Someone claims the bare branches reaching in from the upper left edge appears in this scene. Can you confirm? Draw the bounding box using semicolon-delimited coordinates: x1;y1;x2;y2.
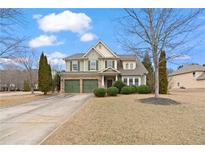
0;9;26;58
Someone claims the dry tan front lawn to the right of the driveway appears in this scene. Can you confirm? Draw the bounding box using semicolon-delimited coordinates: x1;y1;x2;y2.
43;91;205;144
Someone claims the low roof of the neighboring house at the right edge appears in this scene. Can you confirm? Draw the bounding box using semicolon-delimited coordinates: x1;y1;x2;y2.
169;64;205;76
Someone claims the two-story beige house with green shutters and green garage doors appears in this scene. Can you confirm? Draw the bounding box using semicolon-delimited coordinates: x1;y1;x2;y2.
60;41;147;93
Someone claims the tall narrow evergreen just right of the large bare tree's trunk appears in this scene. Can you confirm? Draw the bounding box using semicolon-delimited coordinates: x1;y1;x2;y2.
159;51;168;94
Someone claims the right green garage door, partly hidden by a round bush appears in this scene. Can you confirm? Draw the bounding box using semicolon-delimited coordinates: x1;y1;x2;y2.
83;79;98;93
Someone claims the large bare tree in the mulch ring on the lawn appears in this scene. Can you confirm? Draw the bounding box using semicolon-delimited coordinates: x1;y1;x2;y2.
119;8;203;98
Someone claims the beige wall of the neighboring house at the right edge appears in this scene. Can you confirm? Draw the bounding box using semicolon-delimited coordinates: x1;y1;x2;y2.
168;72;205;89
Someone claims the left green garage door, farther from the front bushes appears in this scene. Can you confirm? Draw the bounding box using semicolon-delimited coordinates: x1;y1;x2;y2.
65;80;80;93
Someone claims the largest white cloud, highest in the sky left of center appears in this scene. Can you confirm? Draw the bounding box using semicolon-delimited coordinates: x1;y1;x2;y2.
38;10;92;34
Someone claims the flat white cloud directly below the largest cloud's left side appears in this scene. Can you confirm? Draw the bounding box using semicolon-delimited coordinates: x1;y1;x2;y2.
29;35;63;48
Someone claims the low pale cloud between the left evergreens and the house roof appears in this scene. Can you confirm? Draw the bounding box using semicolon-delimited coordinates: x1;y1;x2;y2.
46;51;66;65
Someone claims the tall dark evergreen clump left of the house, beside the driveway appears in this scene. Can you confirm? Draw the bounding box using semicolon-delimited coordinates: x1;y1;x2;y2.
38;53;52;95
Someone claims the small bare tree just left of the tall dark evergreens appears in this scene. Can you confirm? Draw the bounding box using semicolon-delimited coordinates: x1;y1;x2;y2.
16;50;38;94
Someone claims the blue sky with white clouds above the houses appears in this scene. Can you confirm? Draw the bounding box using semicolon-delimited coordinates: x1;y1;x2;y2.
1;9;205;69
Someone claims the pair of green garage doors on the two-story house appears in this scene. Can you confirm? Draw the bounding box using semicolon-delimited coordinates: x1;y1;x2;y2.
64;79;98;93
